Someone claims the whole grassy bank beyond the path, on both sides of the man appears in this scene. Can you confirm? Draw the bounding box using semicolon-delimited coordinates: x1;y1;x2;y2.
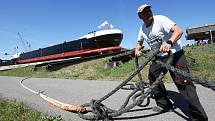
0;44;215;82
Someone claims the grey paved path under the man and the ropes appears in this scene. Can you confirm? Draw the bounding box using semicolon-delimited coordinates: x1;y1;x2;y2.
0;76;215;121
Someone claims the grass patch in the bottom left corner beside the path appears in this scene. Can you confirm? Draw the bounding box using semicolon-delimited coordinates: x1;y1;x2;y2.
0;98;62;121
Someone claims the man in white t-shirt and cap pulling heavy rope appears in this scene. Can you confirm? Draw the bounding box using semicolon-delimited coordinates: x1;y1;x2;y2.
135;4;208;121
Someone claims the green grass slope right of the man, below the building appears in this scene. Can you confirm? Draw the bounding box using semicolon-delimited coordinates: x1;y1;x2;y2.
185;44;215;82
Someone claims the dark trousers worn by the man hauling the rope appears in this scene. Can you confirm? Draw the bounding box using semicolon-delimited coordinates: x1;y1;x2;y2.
148;50;208;121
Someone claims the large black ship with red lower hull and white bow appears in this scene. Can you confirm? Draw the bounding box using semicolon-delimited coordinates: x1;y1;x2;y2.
13;29;123;64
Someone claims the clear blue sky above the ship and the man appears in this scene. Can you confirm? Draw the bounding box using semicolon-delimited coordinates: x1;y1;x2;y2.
0;0;215;59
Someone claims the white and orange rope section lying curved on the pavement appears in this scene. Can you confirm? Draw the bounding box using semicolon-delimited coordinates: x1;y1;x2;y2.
20;77;86;113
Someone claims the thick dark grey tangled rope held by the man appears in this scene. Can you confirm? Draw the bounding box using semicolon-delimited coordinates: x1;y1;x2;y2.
79;52;215;120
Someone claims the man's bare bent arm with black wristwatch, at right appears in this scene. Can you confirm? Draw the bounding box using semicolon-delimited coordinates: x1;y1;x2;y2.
160;25;183;52
